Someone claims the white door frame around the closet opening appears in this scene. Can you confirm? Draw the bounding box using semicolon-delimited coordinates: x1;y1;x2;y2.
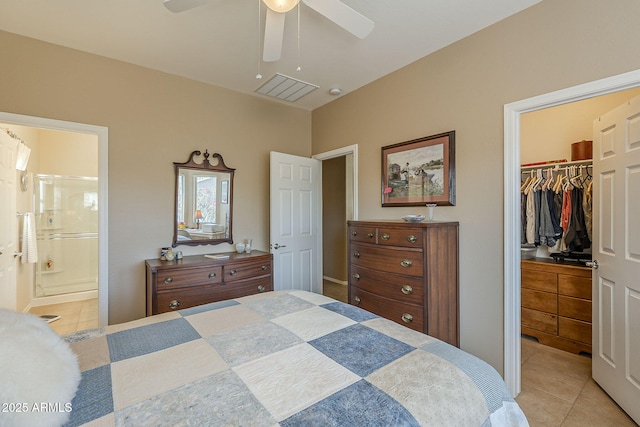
503;70;640;396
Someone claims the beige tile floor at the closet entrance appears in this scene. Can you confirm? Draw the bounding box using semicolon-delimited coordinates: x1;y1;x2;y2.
516;337;637;427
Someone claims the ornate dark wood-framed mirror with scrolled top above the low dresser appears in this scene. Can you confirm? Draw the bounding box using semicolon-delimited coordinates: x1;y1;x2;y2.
173;150;235;247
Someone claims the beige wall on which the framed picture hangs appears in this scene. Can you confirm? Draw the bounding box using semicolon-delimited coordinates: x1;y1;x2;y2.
313;0;640;372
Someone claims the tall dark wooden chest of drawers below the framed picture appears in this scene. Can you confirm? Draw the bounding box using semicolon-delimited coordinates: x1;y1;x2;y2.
348;221;460;347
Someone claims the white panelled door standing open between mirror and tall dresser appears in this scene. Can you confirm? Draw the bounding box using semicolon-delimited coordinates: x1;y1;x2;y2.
270;152;322;293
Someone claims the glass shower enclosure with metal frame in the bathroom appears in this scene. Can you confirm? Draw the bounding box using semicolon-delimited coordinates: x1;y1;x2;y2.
34;175;98;297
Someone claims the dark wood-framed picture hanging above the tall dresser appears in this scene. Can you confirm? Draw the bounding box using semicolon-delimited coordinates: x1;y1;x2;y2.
382;130;456;207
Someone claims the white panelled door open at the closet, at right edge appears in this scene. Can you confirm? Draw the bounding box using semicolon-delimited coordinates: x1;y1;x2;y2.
592;93;640;423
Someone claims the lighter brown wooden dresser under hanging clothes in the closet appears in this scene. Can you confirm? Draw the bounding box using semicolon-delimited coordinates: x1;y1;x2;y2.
521;258;591;353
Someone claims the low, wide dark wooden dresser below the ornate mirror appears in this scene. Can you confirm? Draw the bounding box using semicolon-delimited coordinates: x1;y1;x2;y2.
145;250;273;316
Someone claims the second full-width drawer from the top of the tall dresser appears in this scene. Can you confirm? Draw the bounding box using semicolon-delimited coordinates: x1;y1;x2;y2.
349;266;424;305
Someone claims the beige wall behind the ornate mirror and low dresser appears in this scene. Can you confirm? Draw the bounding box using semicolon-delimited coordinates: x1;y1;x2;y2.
0;32;311;323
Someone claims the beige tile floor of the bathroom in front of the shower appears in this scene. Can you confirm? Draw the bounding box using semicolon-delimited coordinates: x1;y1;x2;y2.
29;298;98;335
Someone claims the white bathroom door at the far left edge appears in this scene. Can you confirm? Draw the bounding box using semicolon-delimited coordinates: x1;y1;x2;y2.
0;131;18;310
